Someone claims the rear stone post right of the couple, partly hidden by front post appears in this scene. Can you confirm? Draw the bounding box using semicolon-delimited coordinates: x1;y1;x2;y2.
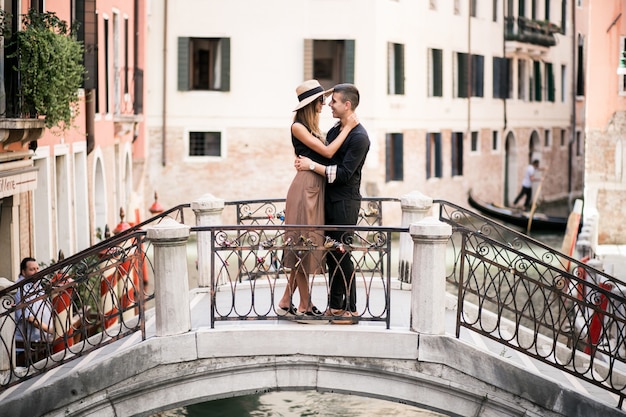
398;191;433;283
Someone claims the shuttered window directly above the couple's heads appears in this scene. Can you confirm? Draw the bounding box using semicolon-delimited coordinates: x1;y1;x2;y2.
304;39;355;88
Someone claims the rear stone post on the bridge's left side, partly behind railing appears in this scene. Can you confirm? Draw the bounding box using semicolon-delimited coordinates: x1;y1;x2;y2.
191;194;224;287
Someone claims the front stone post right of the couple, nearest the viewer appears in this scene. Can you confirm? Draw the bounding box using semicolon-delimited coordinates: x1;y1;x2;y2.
409;217;452;335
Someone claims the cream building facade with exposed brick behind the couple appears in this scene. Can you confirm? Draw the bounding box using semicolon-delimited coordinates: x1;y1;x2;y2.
144;0;584;226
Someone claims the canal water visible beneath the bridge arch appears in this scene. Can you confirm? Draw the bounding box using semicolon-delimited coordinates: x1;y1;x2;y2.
151;391;444;417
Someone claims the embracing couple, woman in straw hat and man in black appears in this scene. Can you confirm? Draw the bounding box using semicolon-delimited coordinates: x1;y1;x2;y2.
277;80;370;324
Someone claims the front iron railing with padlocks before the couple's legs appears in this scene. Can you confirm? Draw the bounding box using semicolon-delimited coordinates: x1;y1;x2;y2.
197;225;400;328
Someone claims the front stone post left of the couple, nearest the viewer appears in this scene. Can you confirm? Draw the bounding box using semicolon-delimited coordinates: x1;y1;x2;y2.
147;218;191;336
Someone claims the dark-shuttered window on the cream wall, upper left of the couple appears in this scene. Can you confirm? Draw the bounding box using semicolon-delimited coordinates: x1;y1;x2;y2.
178;37;230;91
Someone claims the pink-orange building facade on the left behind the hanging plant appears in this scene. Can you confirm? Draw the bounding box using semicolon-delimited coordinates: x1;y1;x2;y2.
0;0;145;279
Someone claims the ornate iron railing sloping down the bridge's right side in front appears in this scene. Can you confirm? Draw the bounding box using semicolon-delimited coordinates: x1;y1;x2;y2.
436;201;626;407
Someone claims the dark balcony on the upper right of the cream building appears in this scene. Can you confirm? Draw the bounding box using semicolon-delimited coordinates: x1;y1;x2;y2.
504;16;561;48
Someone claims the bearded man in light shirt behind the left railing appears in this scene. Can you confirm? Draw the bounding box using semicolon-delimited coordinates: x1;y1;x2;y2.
15;258;54;364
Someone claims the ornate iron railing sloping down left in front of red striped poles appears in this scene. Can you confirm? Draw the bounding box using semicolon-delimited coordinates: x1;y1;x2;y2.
0;205;189;390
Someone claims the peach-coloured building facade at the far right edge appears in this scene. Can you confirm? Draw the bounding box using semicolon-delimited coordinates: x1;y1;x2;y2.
578;0;626;245
